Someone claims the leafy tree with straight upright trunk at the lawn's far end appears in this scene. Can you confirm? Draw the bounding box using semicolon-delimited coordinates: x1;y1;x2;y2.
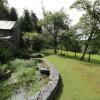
41;11;69;54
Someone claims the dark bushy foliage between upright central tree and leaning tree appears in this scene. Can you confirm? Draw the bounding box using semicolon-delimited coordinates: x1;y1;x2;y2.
59;25;81;55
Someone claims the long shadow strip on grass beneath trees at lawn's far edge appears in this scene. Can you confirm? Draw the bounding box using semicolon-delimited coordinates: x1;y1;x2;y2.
58;54;100;65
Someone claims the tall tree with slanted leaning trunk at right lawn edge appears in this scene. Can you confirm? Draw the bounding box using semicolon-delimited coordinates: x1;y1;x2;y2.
71;0;100;60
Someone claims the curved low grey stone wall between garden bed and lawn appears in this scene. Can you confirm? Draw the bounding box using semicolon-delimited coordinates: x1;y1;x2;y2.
28;60;60;100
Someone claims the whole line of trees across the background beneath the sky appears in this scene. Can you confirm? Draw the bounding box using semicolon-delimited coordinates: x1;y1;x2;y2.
0;0;100;61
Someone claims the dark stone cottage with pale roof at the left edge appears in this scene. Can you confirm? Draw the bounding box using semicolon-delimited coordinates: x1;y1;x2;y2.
0;20;19;48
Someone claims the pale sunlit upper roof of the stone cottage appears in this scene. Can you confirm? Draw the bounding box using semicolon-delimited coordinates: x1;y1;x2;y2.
0;20;16;30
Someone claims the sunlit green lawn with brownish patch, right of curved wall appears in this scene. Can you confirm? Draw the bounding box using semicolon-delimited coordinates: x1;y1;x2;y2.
45;54;100;100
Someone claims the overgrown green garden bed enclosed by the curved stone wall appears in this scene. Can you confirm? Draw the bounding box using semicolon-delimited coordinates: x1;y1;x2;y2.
0;59;48;100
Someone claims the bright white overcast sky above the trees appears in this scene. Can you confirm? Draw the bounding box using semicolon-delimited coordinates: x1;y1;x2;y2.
8;0;82;24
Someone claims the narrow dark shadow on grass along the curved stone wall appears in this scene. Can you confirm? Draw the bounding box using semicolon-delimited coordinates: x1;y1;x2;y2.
53;76;63;100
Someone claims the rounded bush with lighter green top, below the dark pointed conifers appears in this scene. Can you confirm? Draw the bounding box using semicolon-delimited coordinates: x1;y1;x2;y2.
23;32;44;52
